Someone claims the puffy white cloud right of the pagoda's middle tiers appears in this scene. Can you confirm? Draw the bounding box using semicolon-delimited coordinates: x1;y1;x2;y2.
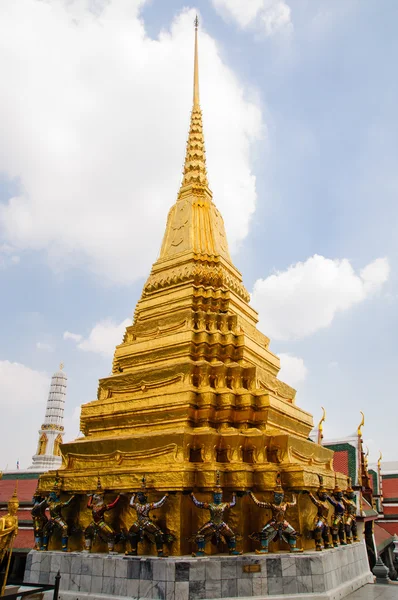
252;254;390;340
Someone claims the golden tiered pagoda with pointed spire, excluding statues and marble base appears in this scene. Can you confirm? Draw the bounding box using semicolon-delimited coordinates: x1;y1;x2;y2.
40;22;345;555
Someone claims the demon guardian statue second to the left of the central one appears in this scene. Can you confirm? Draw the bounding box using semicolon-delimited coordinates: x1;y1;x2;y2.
83;476;120;553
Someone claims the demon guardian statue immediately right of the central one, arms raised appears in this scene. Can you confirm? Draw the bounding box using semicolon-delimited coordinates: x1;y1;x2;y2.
249;473;303;554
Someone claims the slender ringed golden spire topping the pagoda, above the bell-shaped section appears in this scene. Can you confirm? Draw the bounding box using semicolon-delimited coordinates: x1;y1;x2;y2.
179;16;210;197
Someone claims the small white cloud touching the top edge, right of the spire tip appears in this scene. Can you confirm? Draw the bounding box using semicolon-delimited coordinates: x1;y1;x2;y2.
212;0;293;36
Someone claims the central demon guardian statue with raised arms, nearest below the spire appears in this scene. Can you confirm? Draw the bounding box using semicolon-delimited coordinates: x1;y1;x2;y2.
191;471;242;556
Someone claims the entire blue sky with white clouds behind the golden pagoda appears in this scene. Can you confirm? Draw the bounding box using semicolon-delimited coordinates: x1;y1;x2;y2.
0;0;398;470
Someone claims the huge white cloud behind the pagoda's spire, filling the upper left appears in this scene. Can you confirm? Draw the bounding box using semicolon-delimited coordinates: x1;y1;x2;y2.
0;0;263;283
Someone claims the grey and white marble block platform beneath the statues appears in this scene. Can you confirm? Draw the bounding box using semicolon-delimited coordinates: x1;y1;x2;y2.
24;542;373;600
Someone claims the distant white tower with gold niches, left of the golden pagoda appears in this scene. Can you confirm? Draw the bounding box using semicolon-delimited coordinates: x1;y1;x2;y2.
29;363;68;473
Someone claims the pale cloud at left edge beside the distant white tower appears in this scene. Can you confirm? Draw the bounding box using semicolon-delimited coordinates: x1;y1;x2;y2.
0;360;50;470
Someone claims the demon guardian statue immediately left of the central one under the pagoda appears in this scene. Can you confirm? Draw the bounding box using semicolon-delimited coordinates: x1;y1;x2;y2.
128;477;168;556
